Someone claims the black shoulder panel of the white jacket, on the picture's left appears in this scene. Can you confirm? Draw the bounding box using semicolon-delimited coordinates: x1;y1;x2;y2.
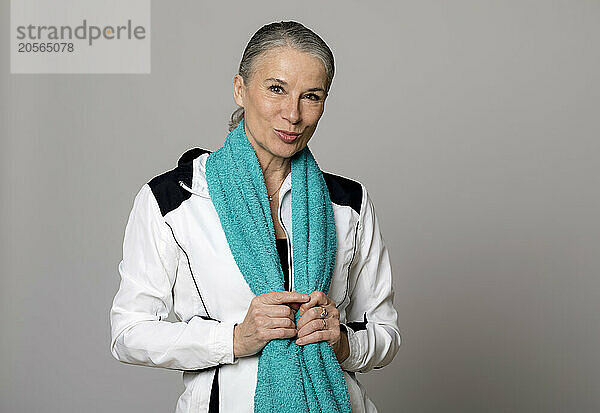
148;148;211;216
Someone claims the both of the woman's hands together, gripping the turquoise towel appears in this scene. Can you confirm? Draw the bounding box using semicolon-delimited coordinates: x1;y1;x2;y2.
233;291;349;362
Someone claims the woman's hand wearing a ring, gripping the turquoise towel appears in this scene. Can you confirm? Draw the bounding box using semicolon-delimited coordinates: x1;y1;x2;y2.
296;291;350;363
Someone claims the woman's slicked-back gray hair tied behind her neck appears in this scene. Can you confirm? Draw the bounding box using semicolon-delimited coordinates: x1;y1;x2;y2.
229;21;335;131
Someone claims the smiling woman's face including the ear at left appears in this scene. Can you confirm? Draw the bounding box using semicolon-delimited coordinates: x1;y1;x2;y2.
234;47;327;160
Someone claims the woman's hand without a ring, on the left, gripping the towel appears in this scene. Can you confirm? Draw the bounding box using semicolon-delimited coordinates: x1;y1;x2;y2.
233;291;310;357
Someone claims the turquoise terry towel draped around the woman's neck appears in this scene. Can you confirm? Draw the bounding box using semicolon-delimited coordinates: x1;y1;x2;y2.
206;120;351;413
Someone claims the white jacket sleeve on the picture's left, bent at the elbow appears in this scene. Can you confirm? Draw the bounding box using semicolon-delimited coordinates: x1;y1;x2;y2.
110;184;237;370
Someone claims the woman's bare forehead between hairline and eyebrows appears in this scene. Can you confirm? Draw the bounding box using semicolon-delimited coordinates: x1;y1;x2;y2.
252;47;327;87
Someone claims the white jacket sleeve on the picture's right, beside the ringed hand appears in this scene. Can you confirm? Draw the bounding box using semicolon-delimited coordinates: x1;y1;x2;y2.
340;185;401;373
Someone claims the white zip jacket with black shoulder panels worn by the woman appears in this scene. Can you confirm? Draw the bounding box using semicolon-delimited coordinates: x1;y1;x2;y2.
110;148;400;413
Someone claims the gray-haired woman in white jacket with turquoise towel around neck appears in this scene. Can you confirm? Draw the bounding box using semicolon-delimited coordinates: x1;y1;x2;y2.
110;21;400;413
